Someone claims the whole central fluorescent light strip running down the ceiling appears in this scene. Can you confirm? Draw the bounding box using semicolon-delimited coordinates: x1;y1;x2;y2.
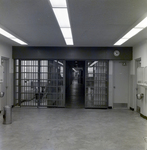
50;0;73;45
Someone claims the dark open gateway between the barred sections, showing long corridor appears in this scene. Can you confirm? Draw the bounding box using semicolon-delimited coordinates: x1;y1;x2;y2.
66;60;85;108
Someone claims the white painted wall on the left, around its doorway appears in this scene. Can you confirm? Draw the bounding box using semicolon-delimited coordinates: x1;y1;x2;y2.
0;42;13;111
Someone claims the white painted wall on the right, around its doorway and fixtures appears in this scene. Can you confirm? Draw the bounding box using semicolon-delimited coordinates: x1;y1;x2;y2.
130;40;147;116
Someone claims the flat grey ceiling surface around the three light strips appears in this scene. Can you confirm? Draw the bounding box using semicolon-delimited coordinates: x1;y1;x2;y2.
0;0;147;46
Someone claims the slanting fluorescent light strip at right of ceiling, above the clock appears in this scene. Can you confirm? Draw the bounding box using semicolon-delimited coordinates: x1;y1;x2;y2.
114;17;147;45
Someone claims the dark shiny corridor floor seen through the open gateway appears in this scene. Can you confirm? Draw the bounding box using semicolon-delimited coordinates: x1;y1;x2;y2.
66;79;84;108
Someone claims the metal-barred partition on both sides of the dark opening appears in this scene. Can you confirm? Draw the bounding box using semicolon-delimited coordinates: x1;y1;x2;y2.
14;59;109;108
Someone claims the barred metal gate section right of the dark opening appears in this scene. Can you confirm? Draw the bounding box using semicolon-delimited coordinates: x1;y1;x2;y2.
85;60;108;108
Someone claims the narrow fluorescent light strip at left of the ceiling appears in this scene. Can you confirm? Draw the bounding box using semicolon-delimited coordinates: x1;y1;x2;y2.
0;28;28;45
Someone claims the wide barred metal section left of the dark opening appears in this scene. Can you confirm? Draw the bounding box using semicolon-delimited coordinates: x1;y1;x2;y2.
14;60;65;107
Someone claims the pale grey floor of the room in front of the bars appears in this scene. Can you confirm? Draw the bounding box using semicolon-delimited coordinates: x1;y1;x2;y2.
0;108;147;150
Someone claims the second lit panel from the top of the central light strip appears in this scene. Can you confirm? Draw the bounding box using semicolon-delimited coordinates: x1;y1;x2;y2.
53;8;70;28
